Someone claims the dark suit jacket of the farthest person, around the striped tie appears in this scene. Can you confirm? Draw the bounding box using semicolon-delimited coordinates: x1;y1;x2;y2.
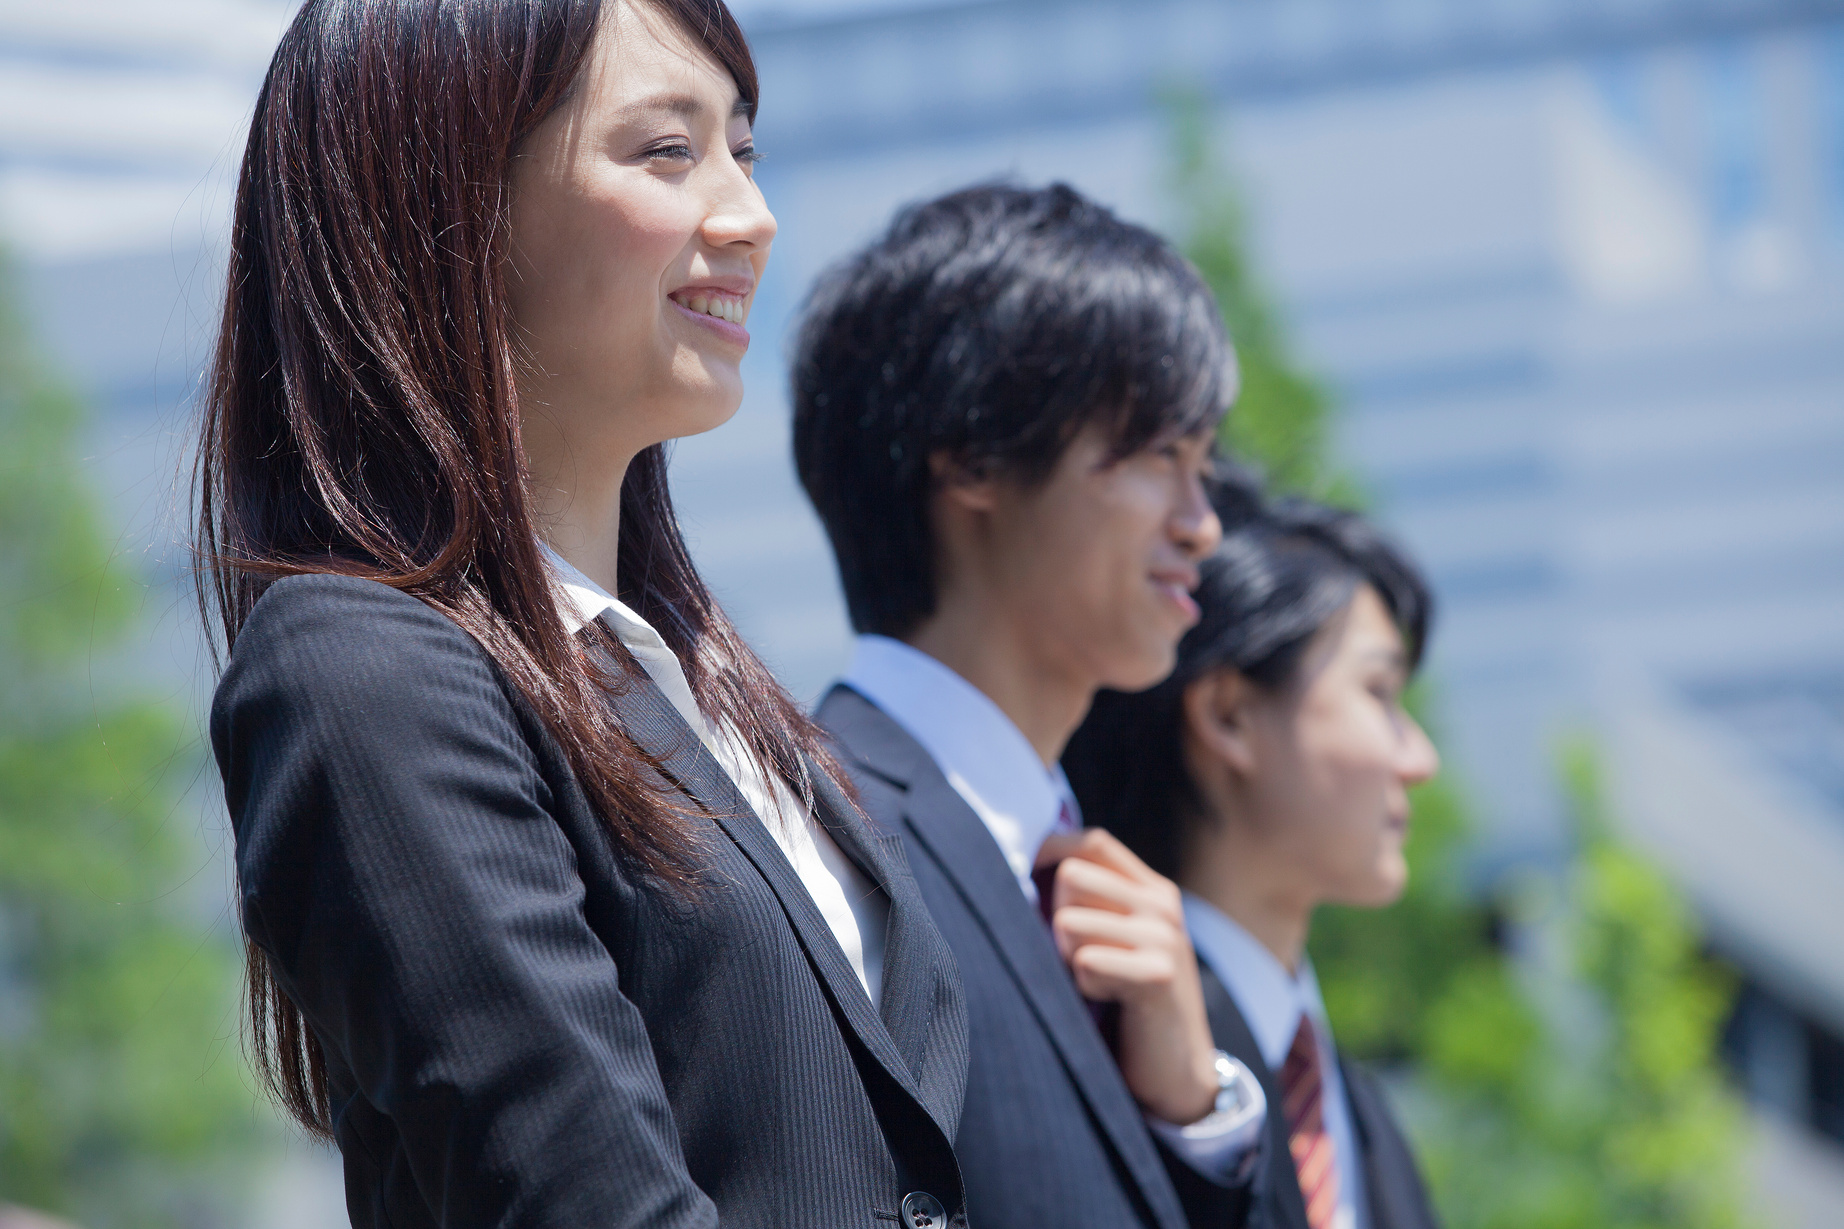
1199;965;1440;1229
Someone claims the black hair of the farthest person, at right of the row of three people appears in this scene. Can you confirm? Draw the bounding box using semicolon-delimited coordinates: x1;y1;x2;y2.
1062;489;1433;878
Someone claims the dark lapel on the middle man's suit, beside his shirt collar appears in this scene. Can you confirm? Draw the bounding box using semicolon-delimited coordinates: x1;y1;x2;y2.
821;686;1186;1229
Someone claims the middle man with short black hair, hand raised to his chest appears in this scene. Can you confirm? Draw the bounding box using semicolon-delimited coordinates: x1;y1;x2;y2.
793;185;1265;1229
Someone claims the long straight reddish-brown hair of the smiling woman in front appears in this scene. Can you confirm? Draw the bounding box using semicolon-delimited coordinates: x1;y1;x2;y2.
195;0;819;1137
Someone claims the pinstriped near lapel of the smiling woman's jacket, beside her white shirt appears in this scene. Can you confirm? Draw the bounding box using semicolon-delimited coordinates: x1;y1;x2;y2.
609;675;953;1139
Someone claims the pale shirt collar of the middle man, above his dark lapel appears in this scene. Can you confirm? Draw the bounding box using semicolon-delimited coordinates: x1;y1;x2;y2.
845;635;1075;897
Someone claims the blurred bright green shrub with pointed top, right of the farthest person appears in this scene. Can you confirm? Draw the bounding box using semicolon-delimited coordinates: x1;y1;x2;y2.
1424;744;1746;1229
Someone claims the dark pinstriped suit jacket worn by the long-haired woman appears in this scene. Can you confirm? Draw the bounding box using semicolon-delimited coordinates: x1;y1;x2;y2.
212;576;966;1229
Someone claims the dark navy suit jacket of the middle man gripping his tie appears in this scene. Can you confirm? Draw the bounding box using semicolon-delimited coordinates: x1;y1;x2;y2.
819;686;1247;1229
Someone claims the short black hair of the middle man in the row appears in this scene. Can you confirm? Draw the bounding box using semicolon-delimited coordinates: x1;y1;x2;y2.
793;185;1235;637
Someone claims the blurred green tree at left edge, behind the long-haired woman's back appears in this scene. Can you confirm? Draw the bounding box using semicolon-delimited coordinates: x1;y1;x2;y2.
0;256;260;1229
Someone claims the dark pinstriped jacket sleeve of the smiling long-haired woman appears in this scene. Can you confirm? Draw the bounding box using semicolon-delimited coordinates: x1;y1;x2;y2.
212;578;717;1229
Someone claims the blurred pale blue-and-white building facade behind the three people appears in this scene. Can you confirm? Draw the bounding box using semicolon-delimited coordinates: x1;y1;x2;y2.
0;0;1844;1210
